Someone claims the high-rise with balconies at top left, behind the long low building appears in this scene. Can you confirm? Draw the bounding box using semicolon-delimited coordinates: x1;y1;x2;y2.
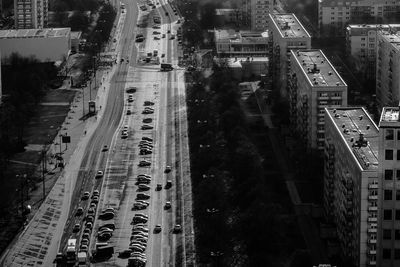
14;0;49;29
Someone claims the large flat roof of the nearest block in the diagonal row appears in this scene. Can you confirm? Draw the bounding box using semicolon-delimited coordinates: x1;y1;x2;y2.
325;107;379;170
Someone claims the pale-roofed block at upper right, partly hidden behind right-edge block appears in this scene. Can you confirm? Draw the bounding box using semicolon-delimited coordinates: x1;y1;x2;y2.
346;24;400;80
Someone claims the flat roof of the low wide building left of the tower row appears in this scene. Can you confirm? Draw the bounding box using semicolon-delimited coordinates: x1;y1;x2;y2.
214;30;269;43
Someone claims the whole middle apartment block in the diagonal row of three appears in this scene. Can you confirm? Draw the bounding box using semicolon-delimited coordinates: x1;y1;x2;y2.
288;49;347;152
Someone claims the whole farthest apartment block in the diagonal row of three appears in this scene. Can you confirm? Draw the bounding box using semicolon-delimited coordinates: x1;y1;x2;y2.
268;13;311;96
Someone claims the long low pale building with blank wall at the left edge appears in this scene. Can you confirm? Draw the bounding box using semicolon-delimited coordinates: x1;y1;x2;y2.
0;28;71;62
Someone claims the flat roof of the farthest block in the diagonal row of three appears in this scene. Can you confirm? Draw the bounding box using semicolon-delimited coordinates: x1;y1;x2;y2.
269;13;311;38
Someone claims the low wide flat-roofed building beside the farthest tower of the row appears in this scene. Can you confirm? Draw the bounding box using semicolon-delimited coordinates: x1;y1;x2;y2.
214;30;269;57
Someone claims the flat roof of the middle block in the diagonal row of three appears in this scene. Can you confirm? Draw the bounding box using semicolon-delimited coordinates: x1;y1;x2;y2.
291;49;347;87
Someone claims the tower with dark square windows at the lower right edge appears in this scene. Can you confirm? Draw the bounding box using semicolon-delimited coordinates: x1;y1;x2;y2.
376;106;400;267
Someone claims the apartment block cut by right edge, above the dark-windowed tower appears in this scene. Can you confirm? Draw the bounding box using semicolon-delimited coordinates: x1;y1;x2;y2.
376;32;400;110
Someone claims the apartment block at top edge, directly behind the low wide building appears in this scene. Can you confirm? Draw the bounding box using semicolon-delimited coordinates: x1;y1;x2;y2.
242;0;276;32
